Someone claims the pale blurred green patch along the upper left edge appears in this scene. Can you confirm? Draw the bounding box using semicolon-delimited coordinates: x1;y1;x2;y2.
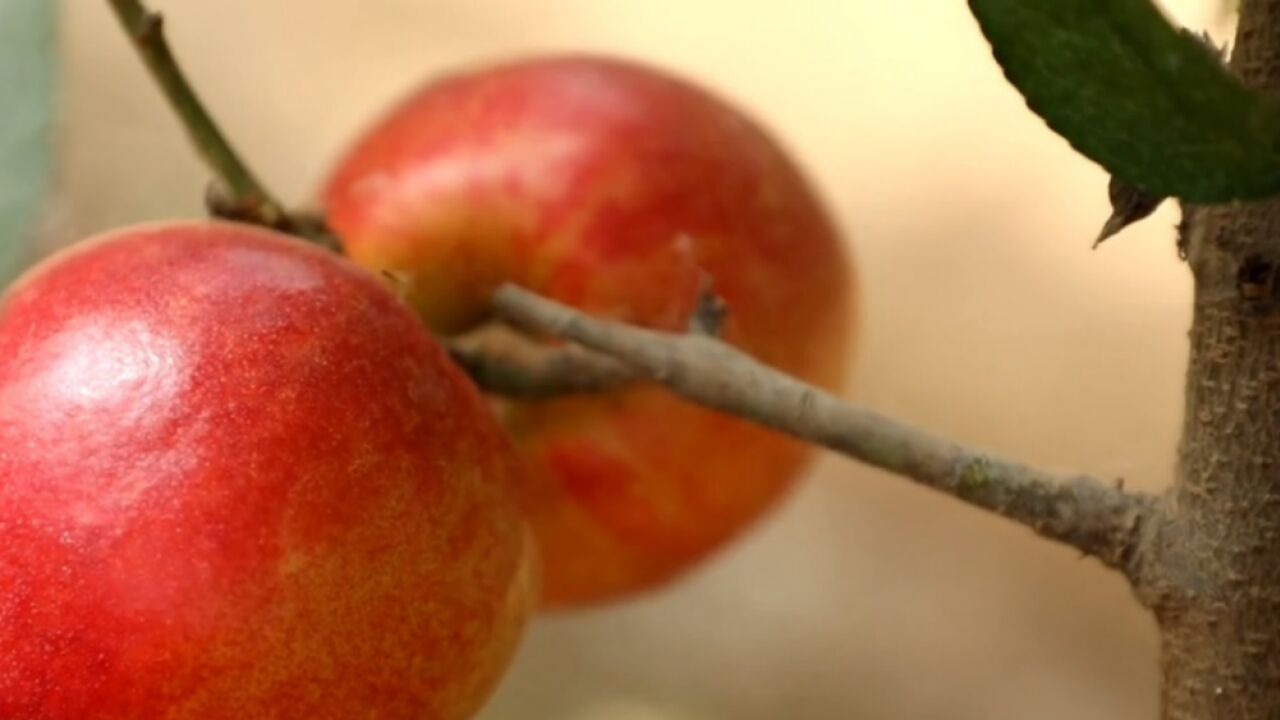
0;0;58;286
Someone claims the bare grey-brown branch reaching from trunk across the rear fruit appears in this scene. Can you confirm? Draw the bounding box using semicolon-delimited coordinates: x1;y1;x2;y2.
494;284;1153;573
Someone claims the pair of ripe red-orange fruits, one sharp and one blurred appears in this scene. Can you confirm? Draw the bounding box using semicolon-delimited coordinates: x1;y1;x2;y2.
0;58;850;720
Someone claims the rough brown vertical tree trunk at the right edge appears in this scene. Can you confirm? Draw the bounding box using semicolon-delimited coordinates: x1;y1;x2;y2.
1133;0;1280;720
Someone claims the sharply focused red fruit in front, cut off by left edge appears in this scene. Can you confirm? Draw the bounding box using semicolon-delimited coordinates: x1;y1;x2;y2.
0;222;536;720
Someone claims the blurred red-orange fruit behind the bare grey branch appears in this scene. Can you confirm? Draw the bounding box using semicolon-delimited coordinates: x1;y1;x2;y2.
323;56;854;607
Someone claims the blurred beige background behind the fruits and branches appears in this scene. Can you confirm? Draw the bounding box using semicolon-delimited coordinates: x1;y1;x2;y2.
50;0;1226;720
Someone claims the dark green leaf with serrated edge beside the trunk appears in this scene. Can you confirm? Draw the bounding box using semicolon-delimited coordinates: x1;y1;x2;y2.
969;0;1280;202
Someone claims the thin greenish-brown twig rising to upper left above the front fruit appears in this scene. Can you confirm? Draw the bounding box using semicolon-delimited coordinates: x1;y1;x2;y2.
110;0;338;250
